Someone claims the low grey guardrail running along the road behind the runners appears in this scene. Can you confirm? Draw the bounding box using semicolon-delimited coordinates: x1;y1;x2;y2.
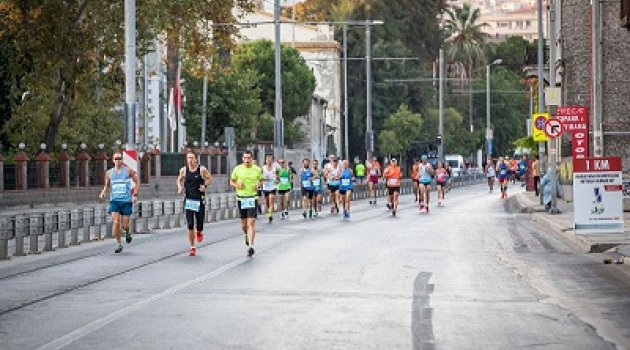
0;175;485;260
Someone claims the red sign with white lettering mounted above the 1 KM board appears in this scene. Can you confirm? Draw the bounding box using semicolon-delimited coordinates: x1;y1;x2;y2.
556;106;589;163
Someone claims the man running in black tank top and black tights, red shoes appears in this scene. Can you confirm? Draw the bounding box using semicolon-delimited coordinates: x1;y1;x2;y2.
177;151;212;256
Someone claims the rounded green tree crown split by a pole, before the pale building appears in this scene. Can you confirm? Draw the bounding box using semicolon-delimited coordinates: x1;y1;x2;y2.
232;40;315;122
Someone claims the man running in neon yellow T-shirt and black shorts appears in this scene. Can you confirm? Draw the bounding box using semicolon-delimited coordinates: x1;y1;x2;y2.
230;150;262;257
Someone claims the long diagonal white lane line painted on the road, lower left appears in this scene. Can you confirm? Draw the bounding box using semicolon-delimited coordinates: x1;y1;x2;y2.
37;258;250;350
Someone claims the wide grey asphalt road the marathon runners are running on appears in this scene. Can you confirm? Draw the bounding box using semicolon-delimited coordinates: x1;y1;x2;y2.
0;185;630;350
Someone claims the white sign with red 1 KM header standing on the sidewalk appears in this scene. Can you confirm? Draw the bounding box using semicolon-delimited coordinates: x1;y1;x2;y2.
573;157;623;233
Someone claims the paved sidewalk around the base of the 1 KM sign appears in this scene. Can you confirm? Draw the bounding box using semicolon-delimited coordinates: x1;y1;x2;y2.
512;192;630;256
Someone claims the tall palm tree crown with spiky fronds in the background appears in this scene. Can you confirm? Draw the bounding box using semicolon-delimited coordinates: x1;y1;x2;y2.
444;3;490;77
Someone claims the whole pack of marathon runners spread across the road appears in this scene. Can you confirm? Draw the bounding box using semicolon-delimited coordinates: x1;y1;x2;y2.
100;151;456;257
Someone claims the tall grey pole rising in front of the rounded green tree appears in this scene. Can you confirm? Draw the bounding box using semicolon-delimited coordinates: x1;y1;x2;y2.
273;0;284;159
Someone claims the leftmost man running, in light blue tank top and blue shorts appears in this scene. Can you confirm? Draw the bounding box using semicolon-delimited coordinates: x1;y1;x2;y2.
99;151;140;253
